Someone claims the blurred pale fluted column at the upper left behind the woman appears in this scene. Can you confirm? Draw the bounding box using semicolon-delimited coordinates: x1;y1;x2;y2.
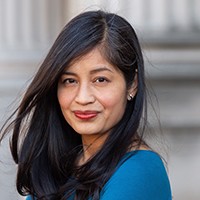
0;0;62;56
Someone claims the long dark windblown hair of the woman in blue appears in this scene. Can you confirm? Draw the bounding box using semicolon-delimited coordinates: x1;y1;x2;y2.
1;11;146;200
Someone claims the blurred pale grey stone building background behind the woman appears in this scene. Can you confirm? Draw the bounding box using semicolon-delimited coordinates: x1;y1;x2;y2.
0;0;200;200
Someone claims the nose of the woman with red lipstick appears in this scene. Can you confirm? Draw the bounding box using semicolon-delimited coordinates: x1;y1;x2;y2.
75;84;95;105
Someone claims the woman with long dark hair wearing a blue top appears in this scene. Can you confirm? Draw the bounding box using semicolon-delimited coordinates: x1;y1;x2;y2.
0;11;171;200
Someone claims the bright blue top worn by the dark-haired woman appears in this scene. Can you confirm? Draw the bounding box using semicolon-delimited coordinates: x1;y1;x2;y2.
26;150;172;200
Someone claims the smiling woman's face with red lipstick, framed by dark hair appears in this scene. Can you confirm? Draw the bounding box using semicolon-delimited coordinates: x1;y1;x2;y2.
57;49;131;141
